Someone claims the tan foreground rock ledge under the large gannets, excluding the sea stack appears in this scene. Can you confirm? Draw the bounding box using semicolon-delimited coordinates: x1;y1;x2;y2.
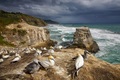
0;48;120;80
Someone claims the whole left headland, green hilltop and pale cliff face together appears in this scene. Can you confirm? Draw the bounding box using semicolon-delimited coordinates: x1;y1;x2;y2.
0;10;50;46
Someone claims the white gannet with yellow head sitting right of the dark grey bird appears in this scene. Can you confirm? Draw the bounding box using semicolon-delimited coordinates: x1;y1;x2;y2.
39;55;55;69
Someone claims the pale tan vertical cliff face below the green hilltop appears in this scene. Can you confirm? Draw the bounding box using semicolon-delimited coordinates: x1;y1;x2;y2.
1;22;50;46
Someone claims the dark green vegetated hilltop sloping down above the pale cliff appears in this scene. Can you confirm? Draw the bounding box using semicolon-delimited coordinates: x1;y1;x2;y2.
0;10;47;27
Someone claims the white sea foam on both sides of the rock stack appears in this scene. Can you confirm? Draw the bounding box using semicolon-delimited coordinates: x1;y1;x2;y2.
48;24;120;57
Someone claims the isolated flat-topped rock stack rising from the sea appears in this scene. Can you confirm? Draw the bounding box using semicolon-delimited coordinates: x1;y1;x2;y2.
73;27;99;53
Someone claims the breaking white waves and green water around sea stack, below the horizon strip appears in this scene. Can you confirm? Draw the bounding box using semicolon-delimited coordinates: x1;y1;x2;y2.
47;24;120;63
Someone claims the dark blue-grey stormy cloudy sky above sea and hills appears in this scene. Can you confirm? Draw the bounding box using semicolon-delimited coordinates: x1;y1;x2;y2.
0;0;120;23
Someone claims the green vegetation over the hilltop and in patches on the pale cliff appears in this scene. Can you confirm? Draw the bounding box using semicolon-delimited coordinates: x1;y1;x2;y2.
0;10;47;45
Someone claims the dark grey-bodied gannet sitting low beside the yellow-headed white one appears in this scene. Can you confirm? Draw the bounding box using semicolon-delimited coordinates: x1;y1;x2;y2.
23;59;40;74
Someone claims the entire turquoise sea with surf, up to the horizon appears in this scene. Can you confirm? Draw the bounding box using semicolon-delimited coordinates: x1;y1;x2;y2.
47;24;120;64
